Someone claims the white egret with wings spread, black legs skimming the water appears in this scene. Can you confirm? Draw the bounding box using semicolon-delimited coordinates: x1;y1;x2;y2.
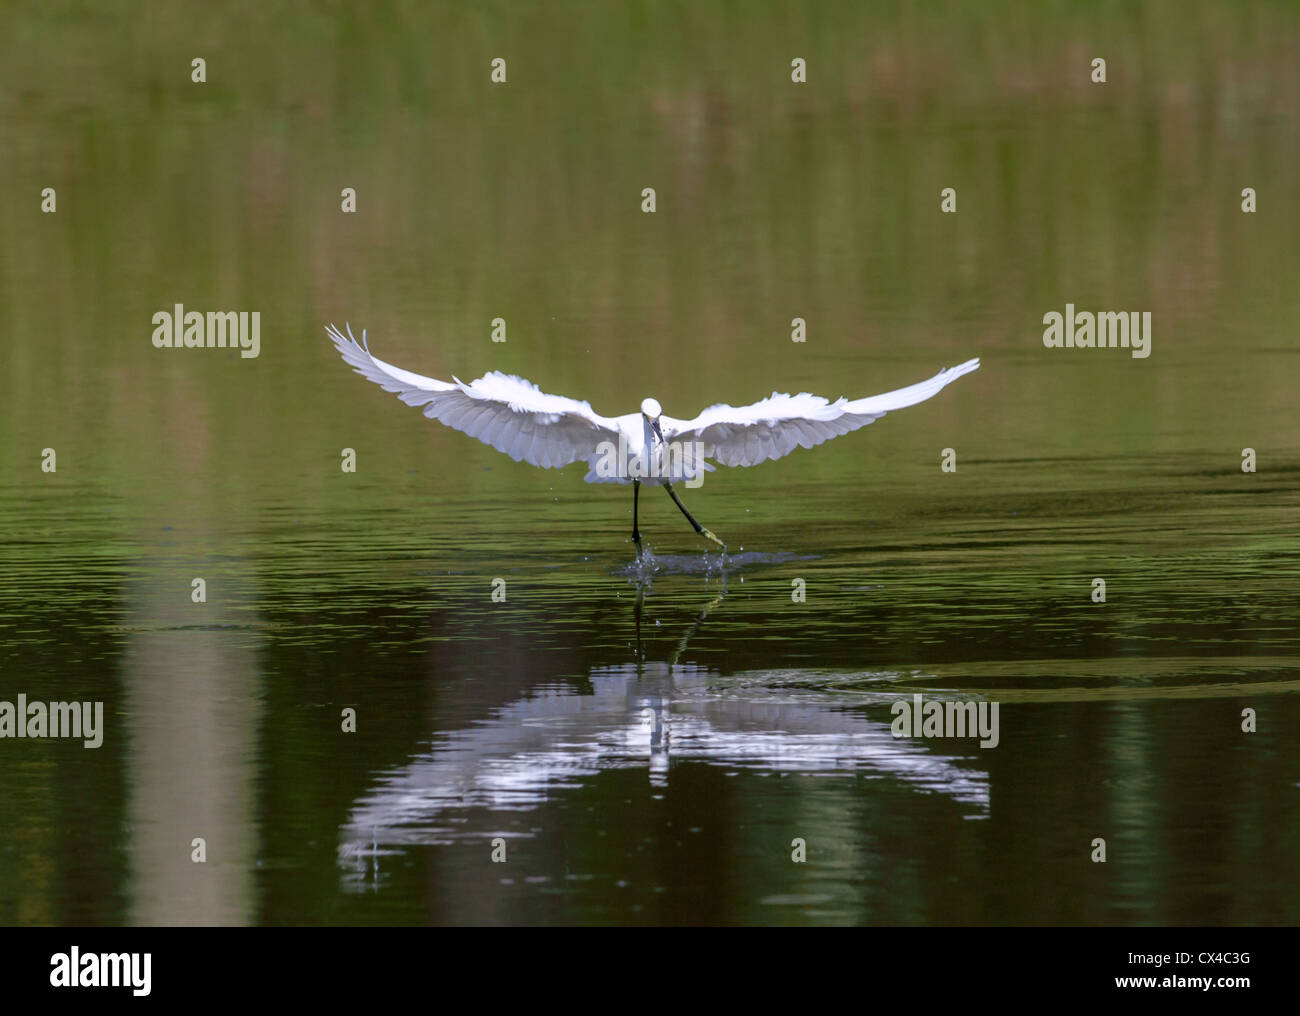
326;325;979;550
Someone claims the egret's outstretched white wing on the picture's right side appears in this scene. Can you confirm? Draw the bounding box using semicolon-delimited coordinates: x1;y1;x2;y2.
659;359;979;465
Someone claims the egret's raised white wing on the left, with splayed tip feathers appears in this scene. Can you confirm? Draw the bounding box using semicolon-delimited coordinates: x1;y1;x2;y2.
325;325;619;469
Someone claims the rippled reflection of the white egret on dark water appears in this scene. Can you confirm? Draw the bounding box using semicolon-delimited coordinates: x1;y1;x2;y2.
338;573;989;890
